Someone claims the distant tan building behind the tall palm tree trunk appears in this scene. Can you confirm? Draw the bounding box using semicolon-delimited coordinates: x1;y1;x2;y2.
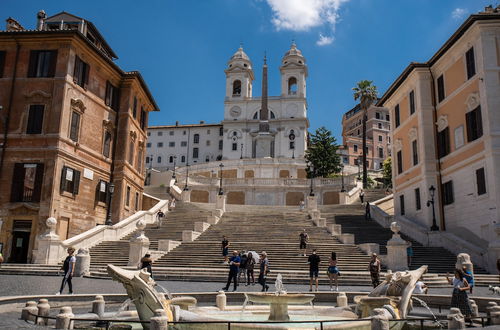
342;104;391;170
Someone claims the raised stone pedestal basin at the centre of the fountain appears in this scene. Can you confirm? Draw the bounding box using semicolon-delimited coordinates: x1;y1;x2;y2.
245;293;315;321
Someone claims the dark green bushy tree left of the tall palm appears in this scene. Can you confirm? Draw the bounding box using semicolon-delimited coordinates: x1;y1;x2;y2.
305;127;340;178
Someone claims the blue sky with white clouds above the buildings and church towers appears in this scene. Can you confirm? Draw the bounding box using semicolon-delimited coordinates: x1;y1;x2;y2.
0;0;496;143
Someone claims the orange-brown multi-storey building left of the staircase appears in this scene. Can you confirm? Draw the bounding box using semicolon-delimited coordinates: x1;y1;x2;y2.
0;11;158;262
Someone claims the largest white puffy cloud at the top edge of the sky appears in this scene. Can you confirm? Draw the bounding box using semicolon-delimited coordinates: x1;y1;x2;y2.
266;0;349;31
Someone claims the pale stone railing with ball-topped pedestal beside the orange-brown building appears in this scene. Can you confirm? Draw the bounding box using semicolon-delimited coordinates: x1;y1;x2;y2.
34;196;168;264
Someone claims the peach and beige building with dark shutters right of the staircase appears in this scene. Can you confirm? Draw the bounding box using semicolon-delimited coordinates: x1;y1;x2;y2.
377;7;500;271
